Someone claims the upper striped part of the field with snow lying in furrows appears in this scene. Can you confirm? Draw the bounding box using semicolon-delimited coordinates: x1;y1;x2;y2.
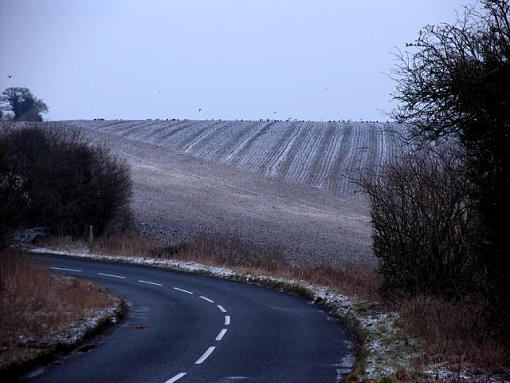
73;120;403;196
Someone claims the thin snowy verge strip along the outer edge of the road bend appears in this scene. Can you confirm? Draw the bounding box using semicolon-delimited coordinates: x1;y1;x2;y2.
29;247;430;381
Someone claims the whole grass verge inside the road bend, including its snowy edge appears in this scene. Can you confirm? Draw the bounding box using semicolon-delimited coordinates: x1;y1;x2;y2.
0;250;123;379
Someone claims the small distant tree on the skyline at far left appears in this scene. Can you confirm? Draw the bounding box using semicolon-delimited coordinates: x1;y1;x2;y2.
0;87;48;121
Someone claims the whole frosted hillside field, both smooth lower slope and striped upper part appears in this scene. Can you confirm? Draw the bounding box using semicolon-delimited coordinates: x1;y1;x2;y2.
67;120;408;264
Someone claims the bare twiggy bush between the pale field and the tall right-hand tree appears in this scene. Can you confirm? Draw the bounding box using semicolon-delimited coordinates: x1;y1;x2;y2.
362;147;483;299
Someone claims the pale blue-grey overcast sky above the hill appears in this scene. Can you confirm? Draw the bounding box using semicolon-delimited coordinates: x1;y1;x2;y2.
0;0;467;120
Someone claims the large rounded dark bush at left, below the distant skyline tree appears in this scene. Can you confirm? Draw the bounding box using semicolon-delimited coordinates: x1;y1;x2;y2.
0;124;131;242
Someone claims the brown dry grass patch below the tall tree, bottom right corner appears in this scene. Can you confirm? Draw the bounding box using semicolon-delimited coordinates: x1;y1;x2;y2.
399;297;510;377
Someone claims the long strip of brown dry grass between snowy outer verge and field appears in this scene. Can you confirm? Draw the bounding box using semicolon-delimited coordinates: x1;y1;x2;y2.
44;230;381;300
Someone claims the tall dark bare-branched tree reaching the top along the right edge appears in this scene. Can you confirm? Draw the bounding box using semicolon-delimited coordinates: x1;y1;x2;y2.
394;0;510;330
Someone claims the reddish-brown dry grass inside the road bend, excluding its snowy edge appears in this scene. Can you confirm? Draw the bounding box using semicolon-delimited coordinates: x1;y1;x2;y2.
0;250;114;371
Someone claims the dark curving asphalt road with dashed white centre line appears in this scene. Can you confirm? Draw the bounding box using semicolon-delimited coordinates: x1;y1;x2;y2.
26;257;352;383
